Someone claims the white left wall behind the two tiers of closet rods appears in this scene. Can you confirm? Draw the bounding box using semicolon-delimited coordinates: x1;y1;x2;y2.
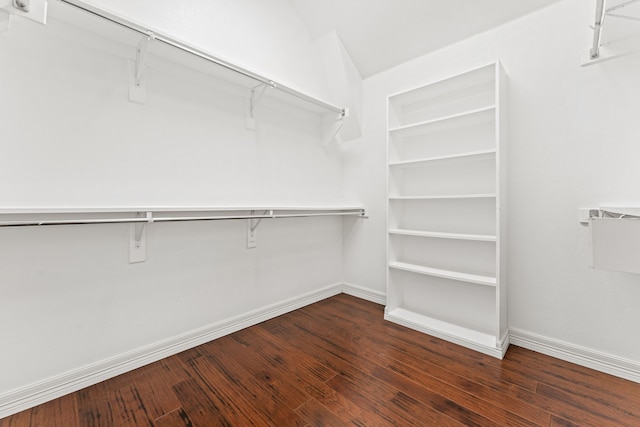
0;0;350;417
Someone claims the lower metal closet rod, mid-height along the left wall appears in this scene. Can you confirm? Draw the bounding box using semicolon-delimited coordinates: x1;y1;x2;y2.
0;209;365;227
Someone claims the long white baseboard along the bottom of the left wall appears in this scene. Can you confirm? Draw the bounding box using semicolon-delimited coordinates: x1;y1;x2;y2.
0;283;344;419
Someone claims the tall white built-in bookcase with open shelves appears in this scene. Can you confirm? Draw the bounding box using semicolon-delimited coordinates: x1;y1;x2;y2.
385;62;508;358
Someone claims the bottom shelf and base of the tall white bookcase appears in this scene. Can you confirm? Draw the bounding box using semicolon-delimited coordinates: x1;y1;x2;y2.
384;308;502;358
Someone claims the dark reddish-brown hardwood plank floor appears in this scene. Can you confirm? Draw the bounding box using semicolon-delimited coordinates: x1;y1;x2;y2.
0;295;640;427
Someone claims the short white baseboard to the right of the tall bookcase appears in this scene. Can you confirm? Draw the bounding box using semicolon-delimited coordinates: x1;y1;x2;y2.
510;328;640;383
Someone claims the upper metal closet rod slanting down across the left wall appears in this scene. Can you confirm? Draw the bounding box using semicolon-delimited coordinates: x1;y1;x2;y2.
58;0;346;117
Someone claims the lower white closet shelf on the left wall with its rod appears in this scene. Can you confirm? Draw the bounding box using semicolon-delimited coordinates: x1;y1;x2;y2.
0;206;366;227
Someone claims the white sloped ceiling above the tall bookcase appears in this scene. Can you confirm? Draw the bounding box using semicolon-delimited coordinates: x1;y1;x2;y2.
289;0;562;78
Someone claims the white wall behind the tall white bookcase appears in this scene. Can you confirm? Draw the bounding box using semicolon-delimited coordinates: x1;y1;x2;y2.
343;0;640;367
